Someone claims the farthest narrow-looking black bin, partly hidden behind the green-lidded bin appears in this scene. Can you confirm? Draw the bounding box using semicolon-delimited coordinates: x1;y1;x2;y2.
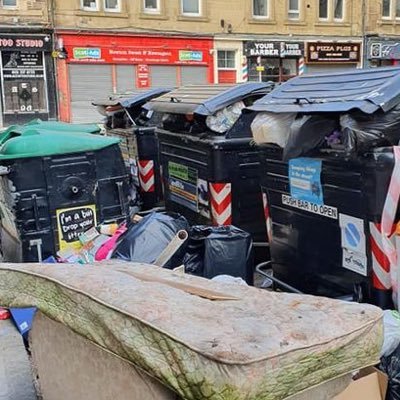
93;88;171;210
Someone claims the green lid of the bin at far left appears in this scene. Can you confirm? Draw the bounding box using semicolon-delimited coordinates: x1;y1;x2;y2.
0;127;119;161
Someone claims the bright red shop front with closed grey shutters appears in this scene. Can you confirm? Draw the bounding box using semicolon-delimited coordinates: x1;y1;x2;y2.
57;33;214;122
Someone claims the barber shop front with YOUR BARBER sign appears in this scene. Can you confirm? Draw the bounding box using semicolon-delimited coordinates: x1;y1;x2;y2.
243;41;304;82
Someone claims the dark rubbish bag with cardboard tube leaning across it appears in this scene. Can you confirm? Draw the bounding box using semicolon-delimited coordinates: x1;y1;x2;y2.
111;213;189;268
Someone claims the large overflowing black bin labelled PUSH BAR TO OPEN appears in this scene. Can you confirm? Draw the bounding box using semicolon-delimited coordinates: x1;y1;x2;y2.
250;68;400;308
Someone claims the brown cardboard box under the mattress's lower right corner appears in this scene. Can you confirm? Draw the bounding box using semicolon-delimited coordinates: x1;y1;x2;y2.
333;367;388;400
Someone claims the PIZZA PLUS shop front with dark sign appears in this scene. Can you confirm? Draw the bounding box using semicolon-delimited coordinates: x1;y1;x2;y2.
305;42;362;73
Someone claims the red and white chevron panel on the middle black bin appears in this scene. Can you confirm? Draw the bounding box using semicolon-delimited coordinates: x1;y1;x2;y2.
210;183;232;225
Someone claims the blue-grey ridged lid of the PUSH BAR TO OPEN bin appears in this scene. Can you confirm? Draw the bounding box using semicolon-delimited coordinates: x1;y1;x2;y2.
248;67;400;114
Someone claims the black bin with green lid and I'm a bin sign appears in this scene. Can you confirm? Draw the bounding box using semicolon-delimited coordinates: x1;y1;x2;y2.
0;129;129;262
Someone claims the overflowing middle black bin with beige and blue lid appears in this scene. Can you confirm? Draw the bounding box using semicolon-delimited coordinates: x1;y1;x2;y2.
145;83;272;247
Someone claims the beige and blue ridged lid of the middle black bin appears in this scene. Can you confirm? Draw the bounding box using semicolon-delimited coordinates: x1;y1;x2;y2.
144;82;274;116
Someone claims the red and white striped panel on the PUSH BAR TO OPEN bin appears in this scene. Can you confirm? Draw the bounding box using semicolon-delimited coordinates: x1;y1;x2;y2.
369;222;393;290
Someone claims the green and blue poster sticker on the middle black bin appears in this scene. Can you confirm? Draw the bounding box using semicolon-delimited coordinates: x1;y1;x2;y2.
168;161;199;212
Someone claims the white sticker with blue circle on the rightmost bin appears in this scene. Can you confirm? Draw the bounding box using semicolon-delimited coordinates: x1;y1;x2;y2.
339;214;368;276
